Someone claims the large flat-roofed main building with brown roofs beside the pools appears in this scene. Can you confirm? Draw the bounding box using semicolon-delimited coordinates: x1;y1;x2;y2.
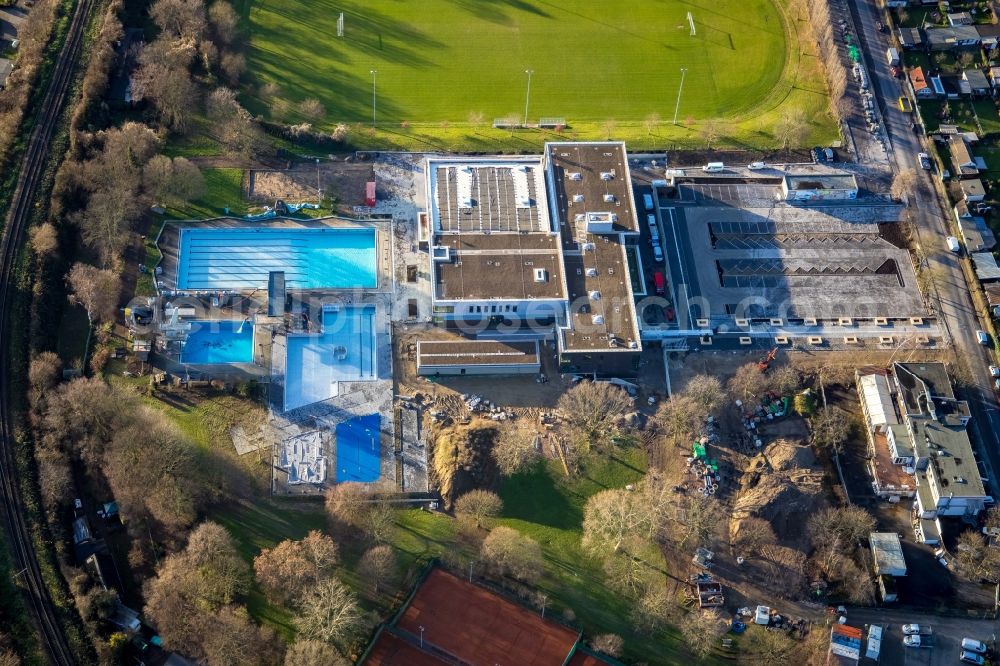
427;142;641;374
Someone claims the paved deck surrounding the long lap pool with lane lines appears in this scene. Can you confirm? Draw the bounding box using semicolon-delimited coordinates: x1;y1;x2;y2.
156;216;392;294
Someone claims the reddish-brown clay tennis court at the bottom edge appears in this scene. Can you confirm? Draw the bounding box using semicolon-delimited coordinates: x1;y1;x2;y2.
365;569;579;666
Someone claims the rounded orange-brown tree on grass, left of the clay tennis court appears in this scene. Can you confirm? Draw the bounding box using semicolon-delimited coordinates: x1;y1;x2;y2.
253;530;340;603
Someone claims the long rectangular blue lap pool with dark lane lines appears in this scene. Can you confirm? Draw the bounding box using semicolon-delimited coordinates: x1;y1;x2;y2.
177;227;377;291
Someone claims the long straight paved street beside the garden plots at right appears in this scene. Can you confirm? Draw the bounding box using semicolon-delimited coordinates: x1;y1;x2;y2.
848;0;1000;482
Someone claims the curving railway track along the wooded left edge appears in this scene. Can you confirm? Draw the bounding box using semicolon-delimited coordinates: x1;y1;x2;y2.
0;0;95;666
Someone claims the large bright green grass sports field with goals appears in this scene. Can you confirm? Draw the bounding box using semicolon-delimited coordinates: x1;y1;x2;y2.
245;0;826;149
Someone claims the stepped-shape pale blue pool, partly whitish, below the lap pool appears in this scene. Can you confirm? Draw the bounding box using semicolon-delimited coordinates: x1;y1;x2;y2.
285;305;378;411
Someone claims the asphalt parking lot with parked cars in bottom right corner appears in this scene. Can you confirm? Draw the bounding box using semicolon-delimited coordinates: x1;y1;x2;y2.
847;608;998;666
